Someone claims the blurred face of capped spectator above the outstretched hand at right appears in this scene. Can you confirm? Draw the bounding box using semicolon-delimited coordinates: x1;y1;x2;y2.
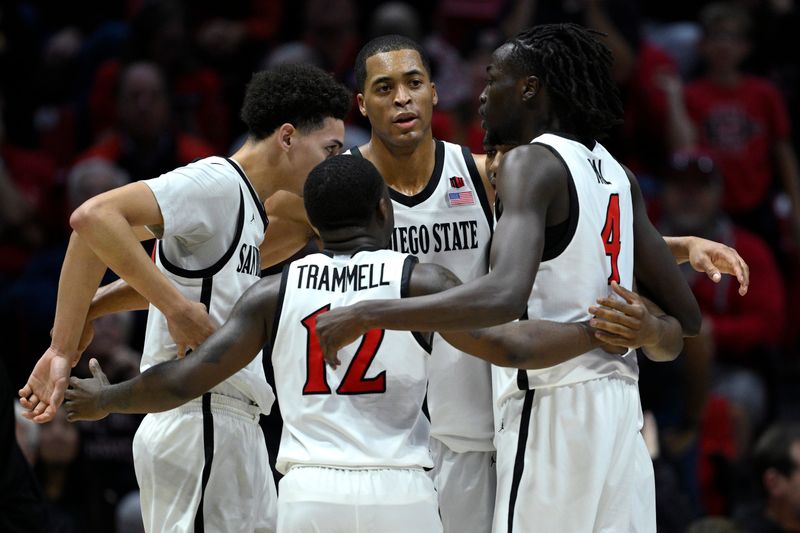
663;160;722;234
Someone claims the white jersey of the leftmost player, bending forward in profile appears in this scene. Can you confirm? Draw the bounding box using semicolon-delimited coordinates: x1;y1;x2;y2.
141;157;275;414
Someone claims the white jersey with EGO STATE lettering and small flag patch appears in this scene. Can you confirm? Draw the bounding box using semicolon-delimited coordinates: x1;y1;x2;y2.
351;140;494;452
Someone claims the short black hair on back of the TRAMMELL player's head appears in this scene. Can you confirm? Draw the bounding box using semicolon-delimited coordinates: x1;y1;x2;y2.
303;155;386;231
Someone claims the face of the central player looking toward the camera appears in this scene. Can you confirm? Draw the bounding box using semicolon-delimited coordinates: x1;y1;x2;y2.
357;50;438;147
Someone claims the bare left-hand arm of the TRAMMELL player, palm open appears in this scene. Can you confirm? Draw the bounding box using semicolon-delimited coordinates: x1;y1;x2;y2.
65;275;281;421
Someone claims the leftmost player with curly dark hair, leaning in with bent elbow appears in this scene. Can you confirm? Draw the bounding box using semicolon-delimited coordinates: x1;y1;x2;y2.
21;66;350;532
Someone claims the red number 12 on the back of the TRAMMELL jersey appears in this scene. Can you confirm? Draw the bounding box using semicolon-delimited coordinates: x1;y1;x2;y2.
301;304;386;394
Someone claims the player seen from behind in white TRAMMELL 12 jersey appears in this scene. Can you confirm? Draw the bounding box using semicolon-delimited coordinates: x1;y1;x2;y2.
61;157;681;533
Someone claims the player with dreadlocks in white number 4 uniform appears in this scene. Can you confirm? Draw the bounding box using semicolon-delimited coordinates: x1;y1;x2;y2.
317;24;701;533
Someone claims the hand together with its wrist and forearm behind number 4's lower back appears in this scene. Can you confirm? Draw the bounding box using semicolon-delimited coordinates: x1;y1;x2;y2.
589;281;683;361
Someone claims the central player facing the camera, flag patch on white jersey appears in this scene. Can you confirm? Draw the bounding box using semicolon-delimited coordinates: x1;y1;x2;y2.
338;35;735;533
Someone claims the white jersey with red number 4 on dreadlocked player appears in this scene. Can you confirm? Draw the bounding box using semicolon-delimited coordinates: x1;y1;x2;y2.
497;133;639;400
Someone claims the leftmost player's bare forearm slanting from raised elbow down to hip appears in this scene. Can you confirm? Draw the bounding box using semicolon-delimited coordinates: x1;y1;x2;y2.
70;205;186;317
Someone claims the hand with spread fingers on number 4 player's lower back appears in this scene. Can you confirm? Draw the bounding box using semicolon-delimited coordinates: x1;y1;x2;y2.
589;281;659;349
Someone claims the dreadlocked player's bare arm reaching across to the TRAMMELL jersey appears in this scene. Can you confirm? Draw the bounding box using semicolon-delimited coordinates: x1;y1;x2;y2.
317;145;564;360
